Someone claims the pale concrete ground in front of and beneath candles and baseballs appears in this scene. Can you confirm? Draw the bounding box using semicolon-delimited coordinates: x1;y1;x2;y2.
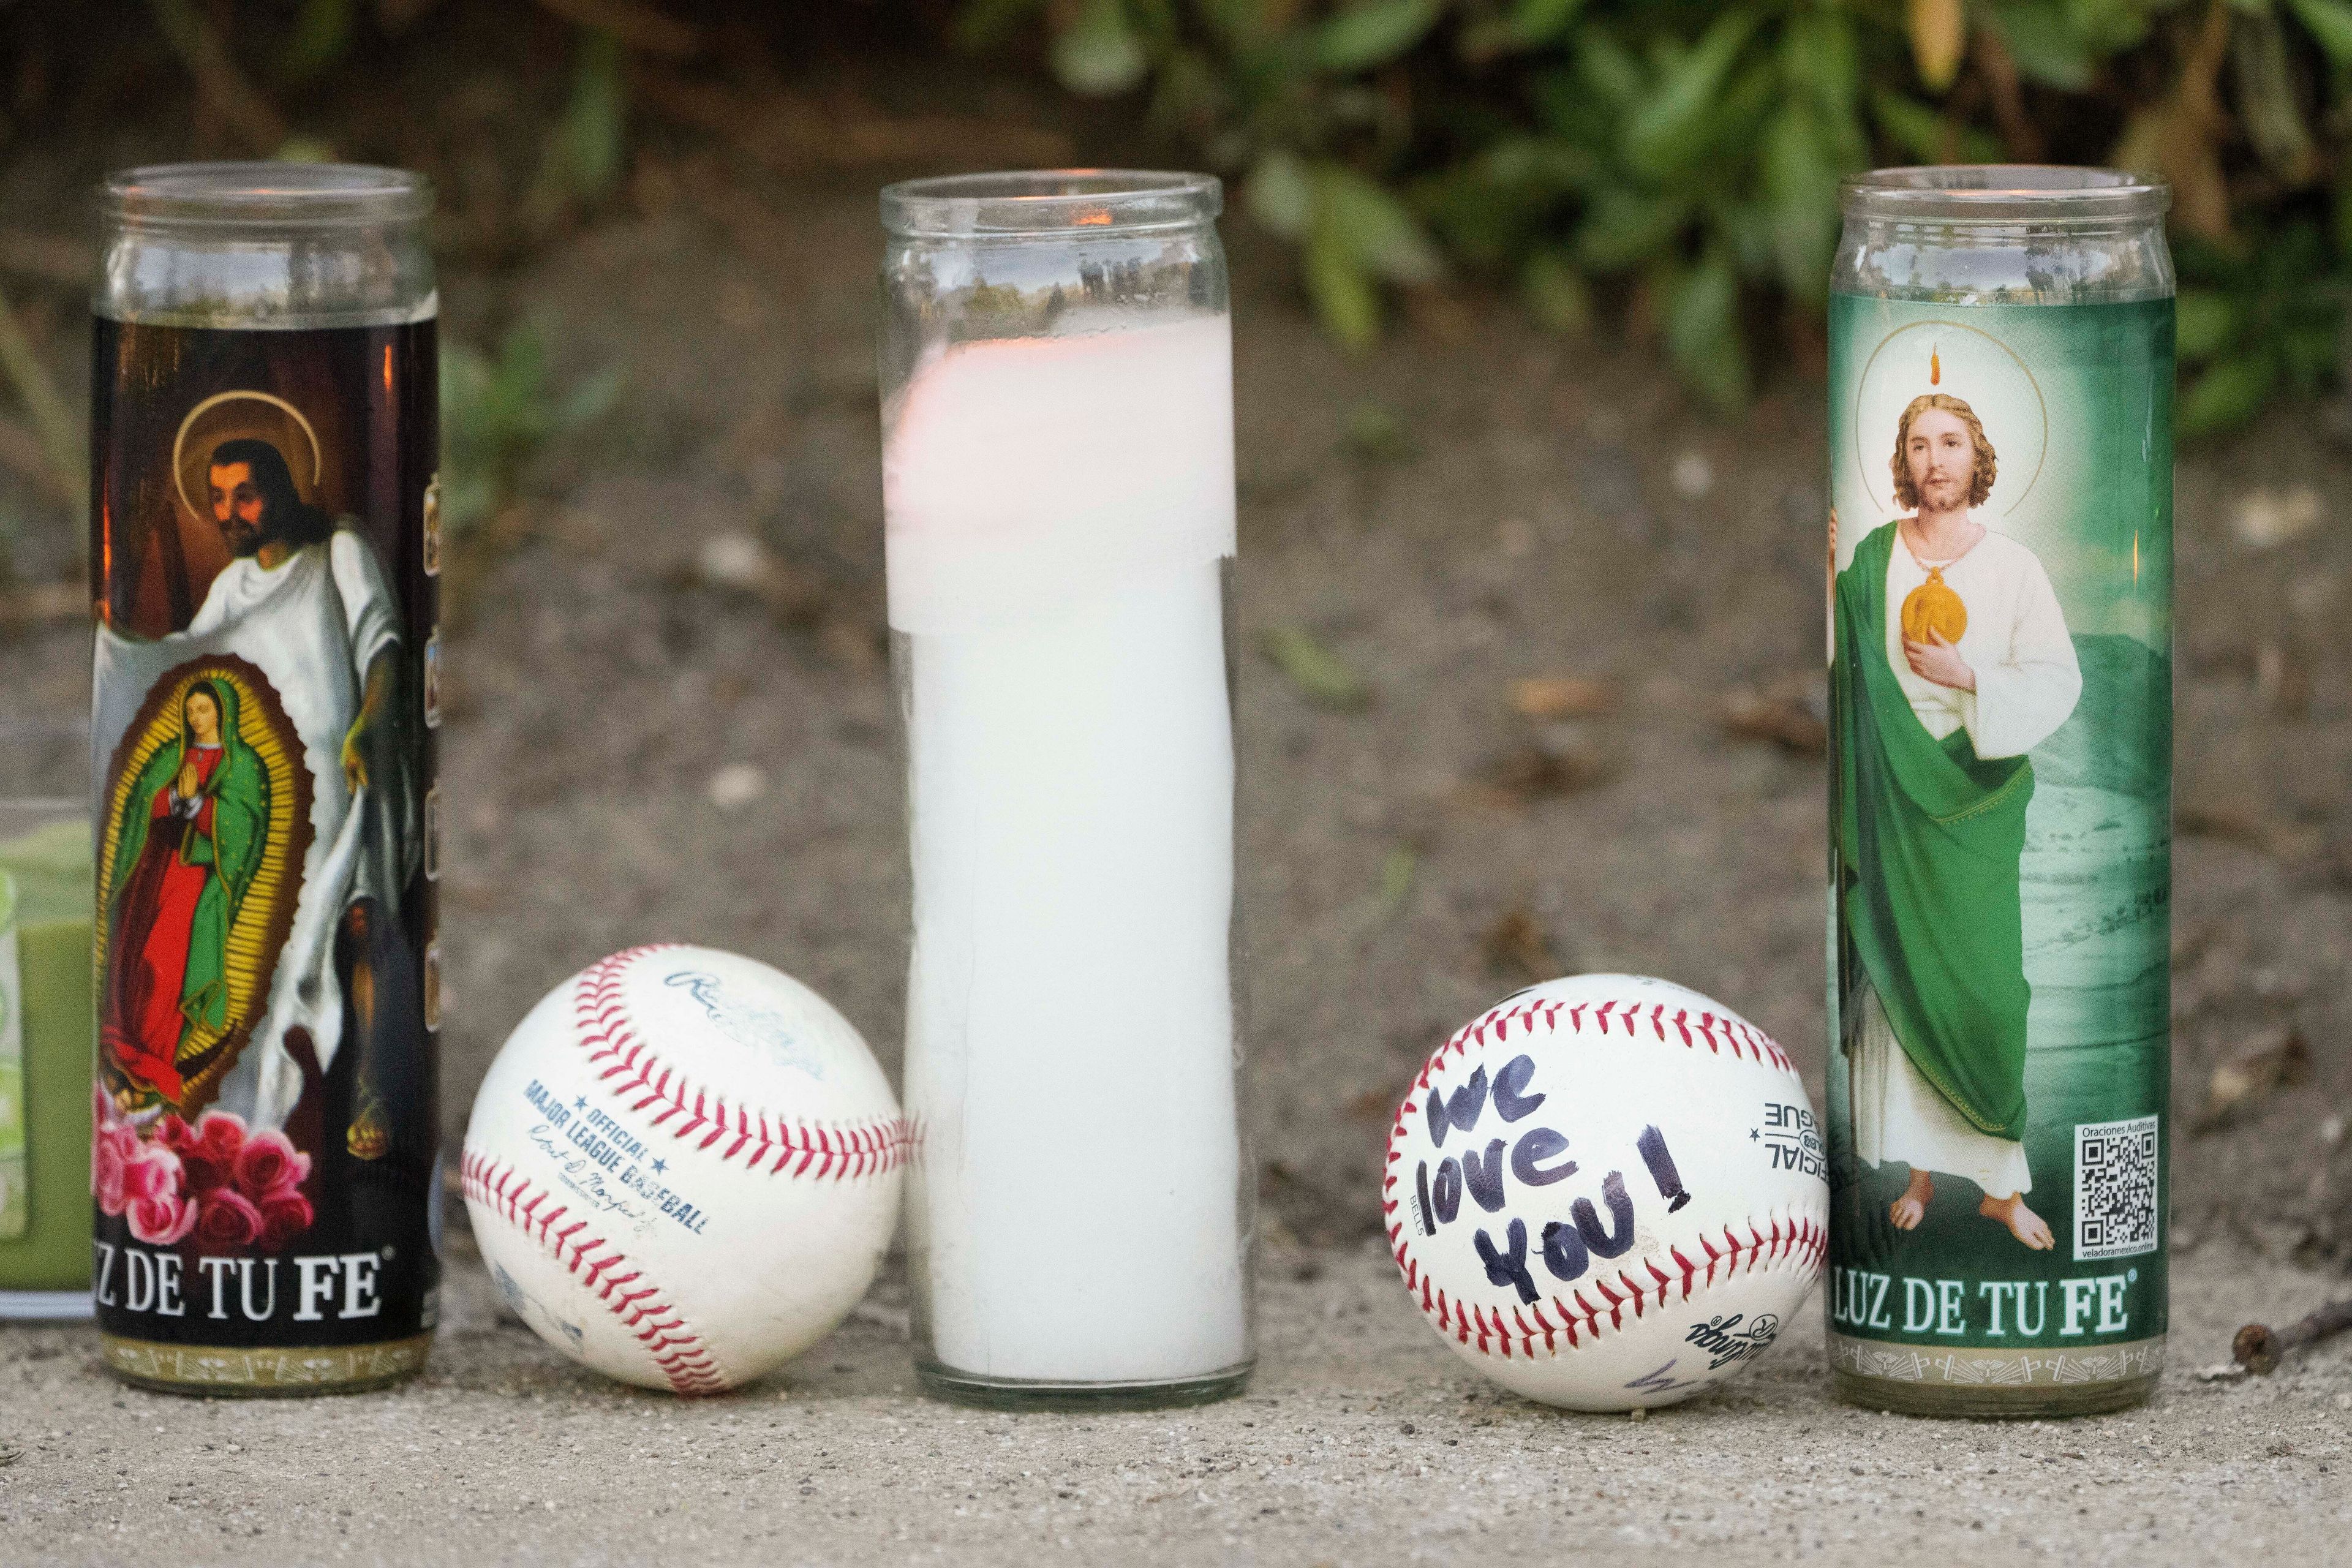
0;1243;2352;1568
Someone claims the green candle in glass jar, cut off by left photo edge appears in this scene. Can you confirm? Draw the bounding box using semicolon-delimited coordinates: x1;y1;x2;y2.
0;719;96;1319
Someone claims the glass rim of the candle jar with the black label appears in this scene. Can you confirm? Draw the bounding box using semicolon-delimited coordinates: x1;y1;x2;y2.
99;160;433;230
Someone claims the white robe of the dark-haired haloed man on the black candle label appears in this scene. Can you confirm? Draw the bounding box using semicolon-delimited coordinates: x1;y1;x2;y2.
89;519;419;1126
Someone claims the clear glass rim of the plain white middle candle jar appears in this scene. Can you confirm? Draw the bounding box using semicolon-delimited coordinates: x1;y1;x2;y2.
882;169;1226;239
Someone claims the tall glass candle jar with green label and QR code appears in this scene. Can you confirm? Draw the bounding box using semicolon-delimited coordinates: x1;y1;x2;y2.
1828;167;2173;1415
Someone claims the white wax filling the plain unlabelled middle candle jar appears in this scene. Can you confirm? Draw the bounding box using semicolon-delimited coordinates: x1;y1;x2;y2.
884;317;1249;1382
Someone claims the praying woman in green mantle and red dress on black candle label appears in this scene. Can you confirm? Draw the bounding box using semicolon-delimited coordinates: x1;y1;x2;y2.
99;679;271;1105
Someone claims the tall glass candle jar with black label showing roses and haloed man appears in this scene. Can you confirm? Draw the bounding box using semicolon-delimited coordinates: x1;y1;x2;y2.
89;165;440;1394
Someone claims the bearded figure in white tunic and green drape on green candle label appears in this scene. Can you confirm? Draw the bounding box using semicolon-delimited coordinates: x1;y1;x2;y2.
1830;376;2081;1251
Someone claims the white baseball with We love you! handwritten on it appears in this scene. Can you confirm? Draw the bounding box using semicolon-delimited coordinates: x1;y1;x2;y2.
1381;976;1830;1411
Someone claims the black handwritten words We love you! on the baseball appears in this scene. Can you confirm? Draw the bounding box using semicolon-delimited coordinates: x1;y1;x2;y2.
1414;1055;1691;1302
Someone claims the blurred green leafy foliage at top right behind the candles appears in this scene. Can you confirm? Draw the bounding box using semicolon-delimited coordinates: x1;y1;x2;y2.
957;0;2352;432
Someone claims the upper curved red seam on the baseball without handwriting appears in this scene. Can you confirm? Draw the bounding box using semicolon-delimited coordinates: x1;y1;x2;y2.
571;943;915;1180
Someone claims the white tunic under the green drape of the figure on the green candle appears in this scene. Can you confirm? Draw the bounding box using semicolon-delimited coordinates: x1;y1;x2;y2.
1846;522;2081;1197
